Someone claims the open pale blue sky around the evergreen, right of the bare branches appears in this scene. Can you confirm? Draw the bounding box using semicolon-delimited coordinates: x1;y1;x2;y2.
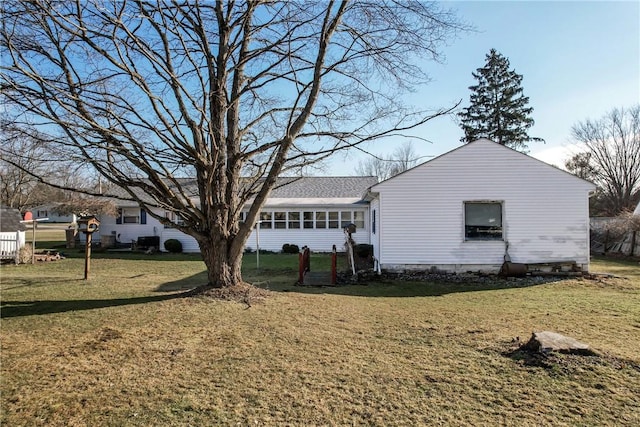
325;0;640;175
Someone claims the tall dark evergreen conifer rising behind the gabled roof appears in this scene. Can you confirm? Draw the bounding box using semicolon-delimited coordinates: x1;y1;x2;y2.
458;49;544;152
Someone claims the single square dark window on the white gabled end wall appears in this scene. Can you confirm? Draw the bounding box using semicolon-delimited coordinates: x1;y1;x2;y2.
464;202;503;240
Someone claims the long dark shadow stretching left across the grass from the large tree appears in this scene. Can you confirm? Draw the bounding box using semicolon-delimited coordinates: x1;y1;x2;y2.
0;293;184;319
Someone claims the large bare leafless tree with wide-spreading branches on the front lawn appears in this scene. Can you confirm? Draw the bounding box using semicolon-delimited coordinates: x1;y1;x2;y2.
1;0;463;287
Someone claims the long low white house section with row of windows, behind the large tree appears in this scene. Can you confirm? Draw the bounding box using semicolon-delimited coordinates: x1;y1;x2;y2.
100;176;377;252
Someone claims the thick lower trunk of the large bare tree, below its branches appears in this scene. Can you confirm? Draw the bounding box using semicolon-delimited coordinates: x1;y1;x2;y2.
198;238;242;288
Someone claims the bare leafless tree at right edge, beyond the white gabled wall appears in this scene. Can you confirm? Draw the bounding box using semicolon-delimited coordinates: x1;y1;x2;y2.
565;105;640;216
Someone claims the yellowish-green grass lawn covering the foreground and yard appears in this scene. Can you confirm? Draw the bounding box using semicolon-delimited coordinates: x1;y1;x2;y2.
0;234;640;426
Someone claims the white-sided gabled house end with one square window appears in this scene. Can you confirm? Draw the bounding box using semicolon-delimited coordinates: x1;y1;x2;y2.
367;139;595;273
